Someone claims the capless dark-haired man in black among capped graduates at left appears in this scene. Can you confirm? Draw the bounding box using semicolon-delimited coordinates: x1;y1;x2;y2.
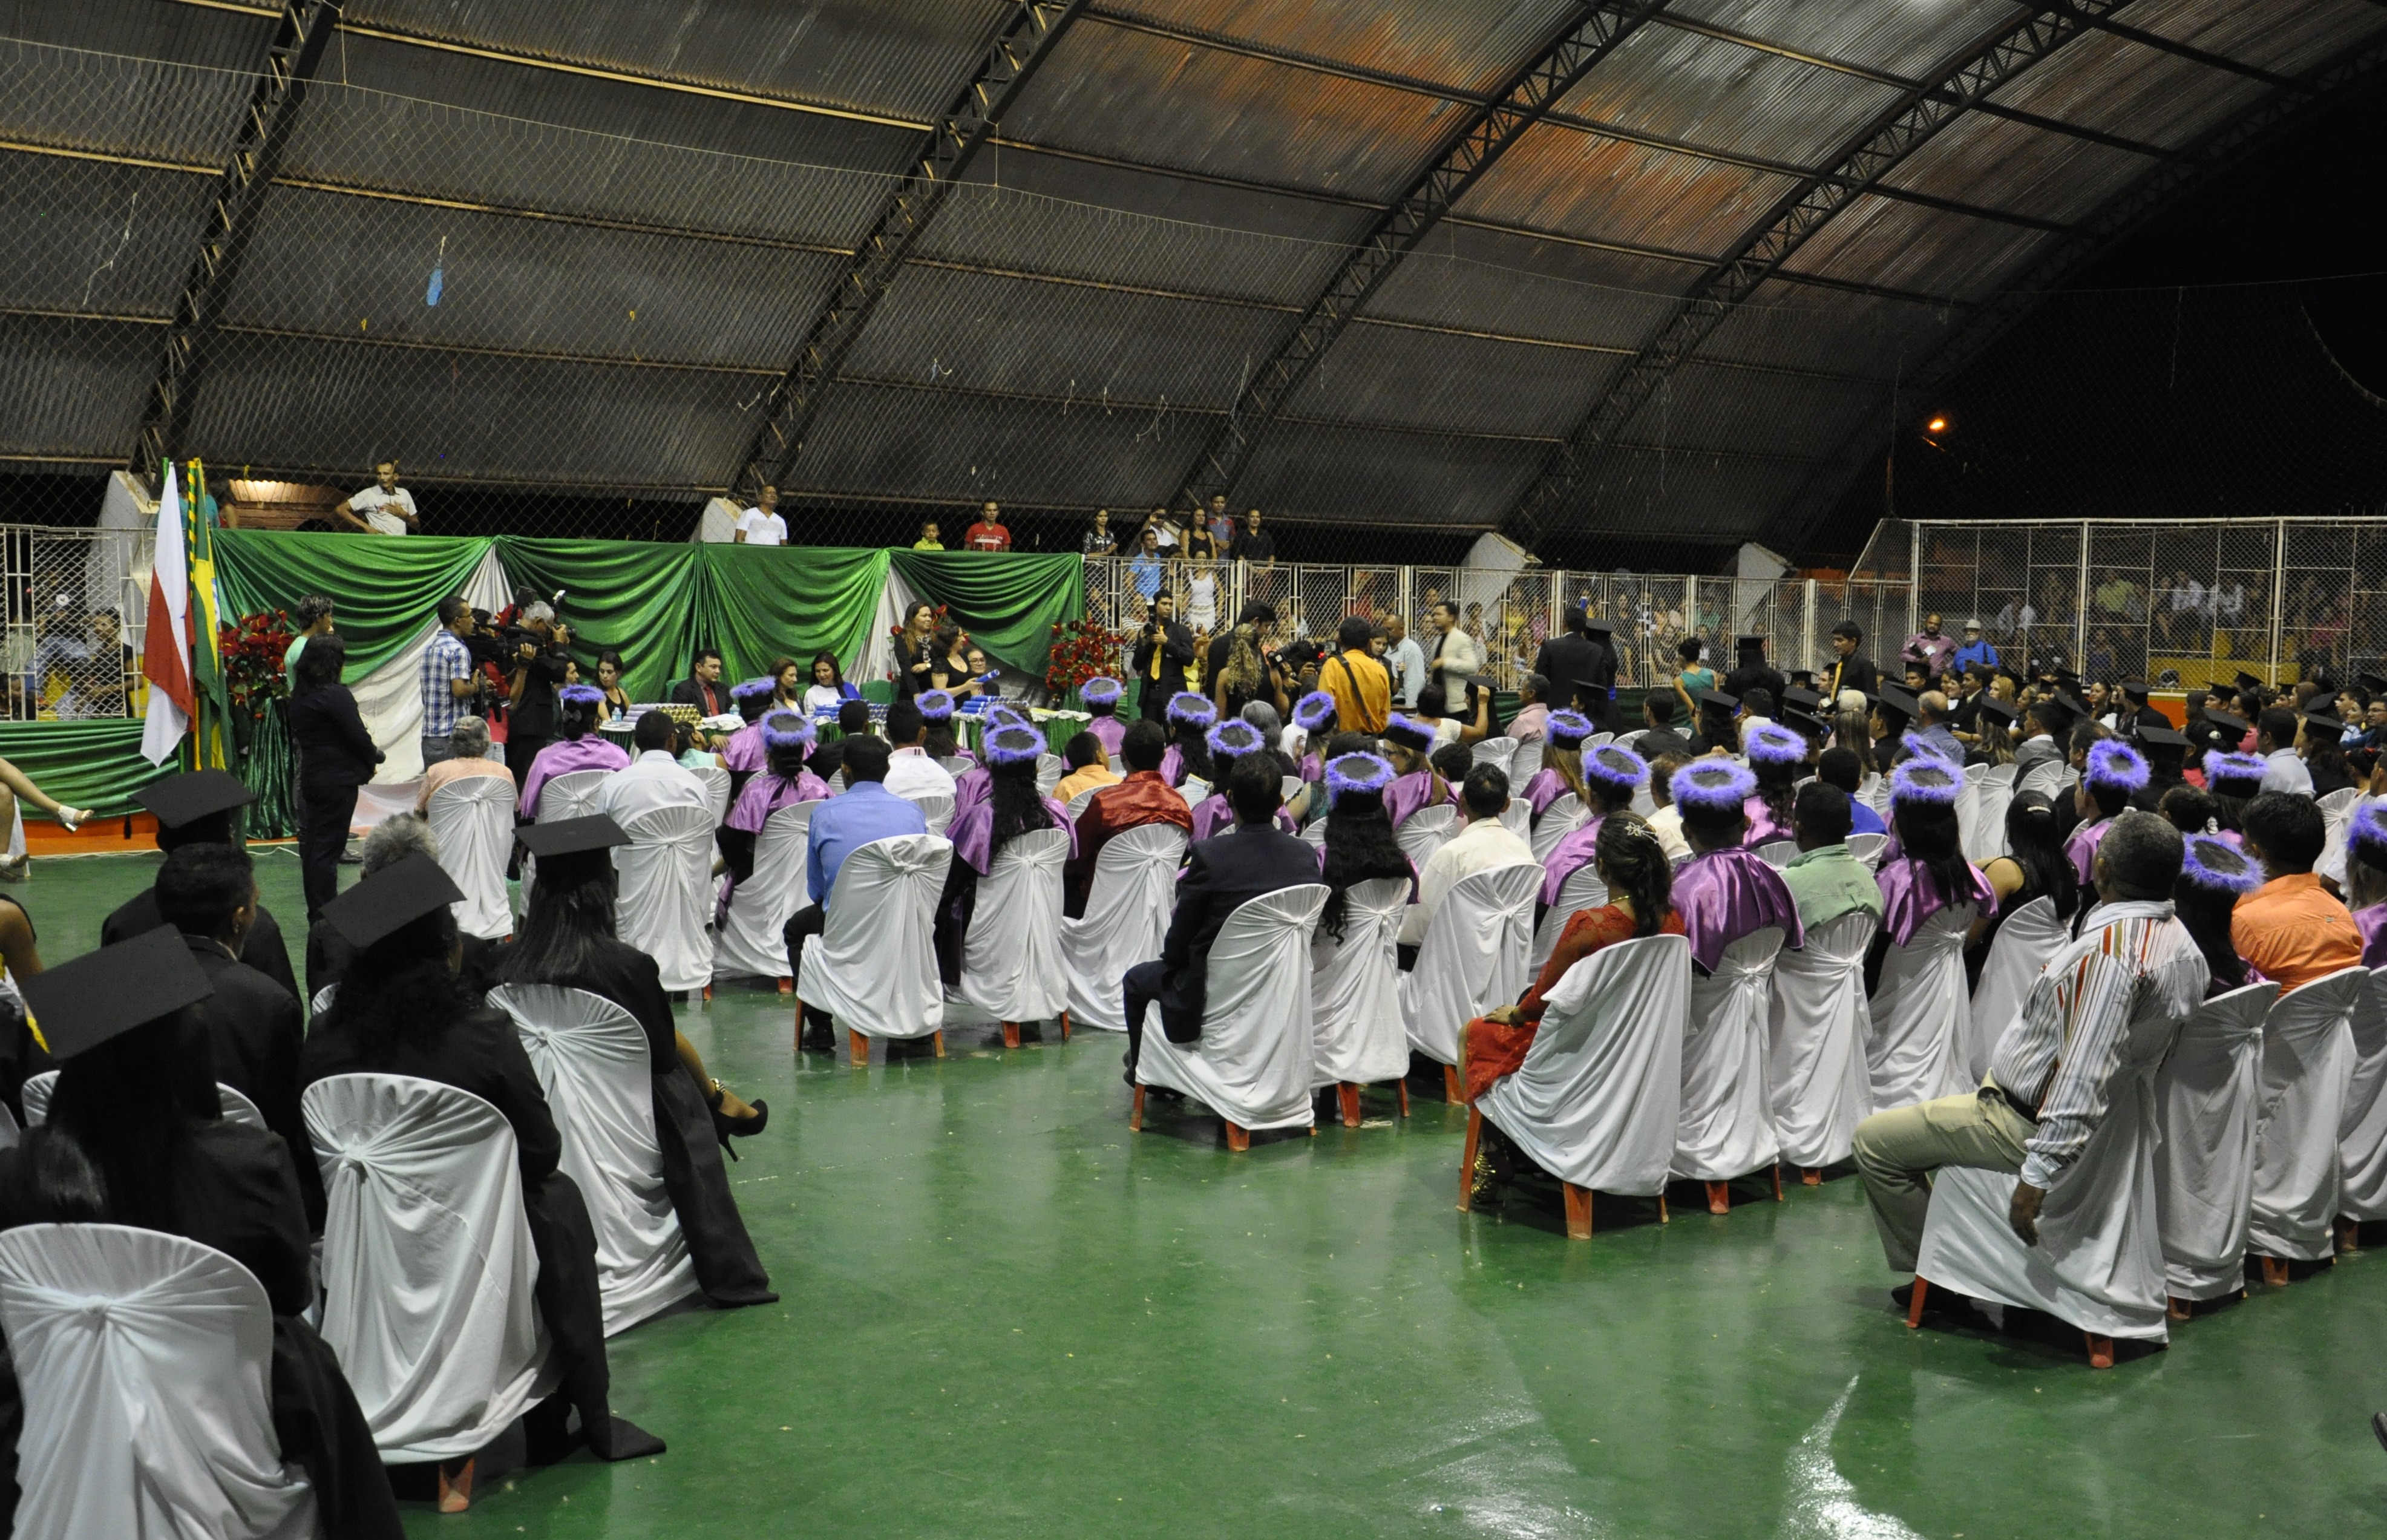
152;845;323;1230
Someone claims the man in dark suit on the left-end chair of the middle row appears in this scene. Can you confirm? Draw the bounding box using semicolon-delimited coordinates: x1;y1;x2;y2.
1122;755;1318;1084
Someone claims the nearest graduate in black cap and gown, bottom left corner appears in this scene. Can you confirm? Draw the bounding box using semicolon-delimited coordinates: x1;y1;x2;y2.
0;931;404;1540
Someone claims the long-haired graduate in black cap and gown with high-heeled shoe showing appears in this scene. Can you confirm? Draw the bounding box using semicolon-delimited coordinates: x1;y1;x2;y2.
497;816;778;1308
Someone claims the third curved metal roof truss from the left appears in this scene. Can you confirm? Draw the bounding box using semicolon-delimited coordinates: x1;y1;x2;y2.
1177;0;1666;520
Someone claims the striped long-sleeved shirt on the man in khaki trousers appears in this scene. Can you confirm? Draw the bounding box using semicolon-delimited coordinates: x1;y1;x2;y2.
1988;900;2208;1189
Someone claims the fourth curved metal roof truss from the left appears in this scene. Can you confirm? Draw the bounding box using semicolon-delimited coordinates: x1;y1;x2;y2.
1501;0;2129;542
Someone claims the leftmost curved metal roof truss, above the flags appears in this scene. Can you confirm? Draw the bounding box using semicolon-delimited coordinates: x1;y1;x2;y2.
131;0;339;477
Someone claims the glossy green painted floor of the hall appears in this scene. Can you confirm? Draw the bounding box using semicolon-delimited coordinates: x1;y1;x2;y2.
12;853;2387;1540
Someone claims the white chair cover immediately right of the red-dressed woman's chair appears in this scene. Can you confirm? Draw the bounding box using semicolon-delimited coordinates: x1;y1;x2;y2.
1673;924;1783;1182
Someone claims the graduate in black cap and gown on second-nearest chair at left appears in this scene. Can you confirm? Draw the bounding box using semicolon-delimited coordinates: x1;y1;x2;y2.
298;859;678;1459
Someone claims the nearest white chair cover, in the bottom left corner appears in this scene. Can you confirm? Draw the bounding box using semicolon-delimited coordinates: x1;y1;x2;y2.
0;1225;318;1540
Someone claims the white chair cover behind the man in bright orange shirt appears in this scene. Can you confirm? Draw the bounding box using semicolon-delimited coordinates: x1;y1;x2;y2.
2246;967;2370;1263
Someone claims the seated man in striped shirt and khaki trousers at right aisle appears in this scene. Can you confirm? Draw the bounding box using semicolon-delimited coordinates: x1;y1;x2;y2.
1857;812;2205;1311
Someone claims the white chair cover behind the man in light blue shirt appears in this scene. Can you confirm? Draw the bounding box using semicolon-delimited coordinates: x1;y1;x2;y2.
795;833;952;1038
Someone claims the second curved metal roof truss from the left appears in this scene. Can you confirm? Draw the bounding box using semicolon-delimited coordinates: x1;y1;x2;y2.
730;0;1086;494
